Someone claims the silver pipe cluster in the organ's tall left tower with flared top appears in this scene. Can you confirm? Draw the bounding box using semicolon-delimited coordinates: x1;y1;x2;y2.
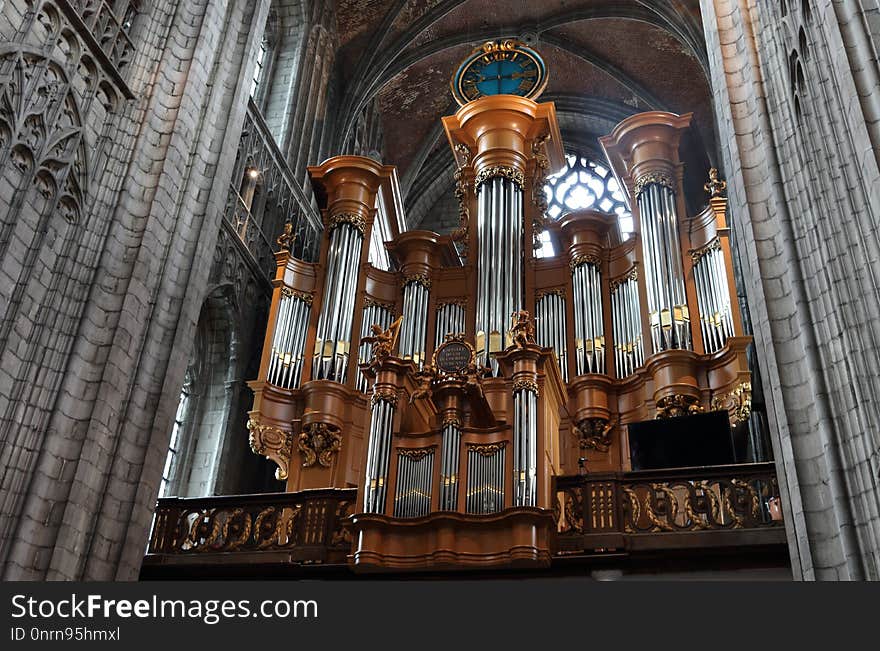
312;221;364;382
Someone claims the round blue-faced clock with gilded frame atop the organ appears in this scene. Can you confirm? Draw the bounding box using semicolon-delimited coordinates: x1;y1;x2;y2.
452;39;547;106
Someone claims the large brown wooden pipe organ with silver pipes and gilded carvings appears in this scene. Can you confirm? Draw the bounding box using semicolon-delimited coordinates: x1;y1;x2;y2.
248;95;751;571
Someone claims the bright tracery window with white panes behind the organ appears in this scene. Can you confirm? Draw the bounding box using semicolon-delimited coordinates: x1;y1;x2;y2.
535;153;633;258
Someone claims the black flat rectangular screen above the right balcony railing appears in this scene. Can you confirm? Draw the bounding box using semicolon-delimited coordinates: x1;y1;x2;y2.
628;411;736;470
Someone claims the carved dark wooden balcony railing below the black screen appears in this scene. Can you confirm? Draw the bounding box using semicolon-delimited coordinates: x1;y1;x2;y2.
555;463;785;554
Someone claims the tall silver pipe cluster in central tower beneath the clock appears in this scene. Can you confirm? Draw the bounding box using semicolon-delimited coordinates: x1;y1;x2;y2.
476;176;523;375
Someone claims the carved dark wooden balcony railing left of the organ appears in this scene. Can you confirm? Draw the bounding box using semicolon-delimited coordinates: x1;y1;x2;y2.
147;489;357;562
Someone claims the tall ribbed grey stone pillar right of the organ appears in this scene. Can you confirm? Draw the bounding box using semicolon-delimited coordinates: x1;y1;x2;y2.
701;0;880;579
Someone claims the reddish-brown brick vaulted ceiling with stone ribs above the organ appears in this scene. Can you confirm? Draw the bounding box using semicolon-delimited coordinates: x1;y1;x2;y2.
336;0;716;230
